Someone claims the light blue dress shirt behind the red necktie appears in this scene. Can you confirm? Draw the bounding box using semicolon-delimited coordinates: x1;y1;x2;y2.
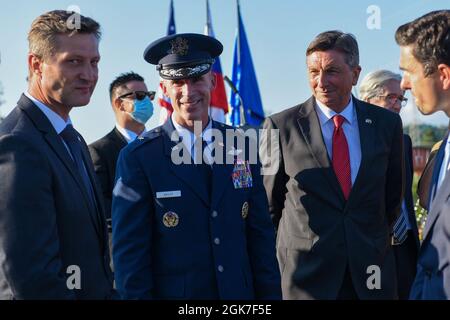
315;97;361;186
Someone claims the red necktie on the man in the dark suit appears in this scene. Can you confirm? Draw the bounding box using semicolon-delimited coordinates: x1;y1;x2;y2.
332;115;352;200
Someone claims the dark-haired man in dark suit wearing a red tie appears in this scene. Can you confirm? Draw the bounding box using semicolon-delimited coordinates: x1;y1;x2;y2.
261;31;404;299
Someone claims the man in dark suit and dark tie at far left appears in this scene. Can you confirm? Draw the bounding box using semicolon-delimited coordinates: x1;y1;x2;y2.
0;10;113;299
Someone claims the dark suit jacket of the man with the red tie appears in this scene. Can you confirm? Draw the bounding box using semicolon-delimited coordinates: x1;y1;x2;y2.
261;97;404;299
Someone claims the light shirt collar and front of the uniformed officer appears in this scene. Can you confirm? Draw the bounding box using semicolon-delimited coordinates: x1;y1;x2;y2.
172;113;213;164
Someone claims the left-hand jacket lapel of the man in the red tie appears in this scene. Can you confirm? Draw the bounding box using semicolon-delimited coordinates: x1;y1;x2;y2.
297;97;344;201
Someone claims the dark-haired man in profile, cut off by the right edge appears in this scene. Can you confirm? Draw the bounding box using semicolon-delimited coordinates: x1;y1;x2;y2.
395;10;450;300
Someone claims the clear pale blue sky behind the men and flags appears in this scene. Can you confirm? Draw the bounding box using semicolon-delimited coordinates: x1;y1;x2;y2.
0;0;450;143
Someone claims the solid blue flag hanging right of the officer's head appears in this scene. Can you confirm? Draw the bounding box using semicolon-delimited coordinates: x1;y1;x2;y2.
230;0;264;126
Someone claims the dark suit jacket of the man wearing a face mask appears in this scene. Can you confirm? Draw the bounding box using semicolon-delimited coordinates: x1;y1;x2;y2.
89;128;128;220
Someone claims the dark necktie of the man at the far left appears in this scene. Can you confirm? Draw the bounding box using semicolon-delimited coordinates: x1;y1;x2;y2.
59;124;96;208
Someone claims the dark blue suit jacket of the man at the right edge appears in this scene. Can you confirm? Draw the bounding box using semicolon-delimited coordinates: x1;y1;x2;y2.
410;137;450;300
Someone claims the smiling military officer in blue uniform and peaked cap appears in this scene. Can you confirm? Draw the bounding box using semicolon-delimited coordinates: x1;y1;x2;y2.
112;34;281;299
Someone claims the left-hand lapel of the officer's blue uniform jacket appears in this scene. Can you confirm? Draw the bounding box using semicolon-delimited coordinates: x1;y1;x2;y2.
162;119;210;206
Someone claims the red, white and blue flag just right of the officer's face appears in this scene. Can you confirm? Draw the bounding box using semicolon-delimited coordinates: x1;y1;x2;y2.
204;0;228;123
